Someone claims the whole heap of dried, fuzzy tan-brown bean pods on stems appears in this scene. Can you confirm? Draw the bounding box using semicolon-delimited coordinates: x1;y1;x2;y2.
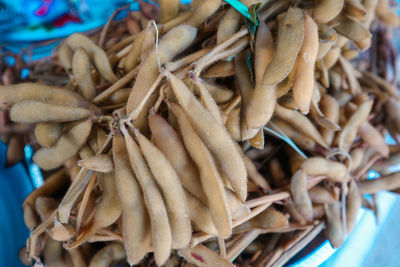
4;0;400;267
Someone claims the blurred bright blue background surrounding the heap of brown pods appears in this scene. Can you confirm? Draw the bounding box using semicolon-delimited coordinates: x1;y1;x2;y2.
0;0;400;267
